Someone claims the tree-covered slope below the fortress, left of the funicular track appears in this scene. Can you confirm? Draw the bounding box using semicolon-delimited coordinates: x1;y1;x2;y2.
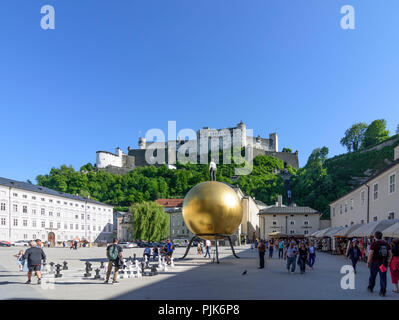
36;156;288;208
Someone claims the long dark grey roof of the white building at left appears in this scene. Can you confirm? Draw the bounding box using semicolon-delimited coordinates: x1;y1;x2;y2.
0;177;112;207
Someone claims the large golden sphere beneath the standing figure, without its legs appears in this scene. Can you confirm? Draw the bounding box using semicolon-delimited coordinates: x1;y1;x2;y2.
183;181;243;240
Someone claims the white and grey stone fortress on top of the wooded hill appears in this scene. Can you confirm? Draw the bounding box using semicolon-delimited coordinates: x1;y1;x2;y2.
96;121;299;174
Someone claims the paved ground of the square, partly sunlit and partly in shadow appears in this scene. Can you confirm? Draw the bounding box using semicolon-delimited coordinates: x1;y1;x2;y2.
0;246;399;300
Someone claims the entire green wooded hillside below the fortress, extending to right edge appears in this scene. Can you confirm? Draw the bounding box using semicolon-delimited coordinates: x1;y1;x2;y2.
37;119;399;218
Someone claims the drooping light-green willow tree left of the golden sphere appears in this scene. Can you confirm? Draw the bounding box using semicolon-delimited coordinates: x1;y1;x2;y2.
130;201;169;241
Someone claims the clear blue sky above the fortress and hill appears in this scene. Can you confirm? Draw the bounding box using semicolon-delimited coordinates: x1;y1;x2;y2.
0;0;399;181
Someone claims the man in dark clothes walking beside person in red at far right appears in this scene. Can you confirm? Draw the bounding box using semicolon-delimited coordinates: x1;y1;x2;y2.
367;231;392;297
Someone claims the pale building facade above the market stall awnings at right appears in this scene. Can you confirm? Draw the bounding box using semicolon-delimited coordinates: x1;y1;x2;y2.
330;146;399;227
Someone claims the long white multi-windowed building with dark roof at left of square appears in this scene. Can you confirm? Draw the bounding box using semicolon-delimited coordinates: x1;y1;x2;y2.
0;178;113;243
